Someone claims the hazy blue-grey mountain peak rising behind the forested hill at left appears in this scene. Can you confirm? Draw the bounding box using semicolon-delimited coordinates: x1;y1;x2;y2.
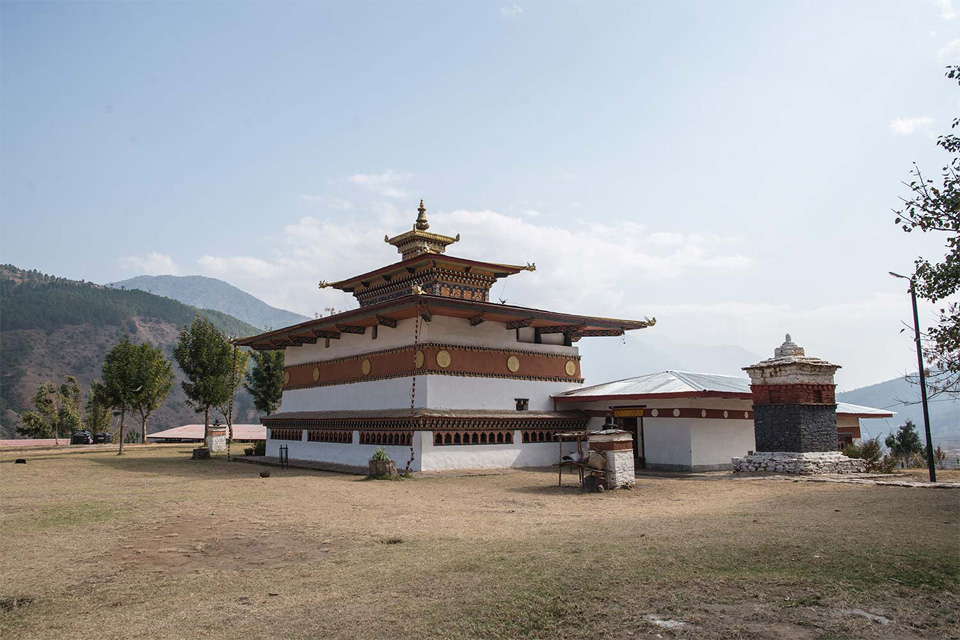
107;276;310;329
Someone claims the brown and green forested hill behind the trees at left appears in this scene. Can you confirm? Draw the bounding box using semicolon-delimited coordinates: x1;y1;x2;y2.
0;265;259;437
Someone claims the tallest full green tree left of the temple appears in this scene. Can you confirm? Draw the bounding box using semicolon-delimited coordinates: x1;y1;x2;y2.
173;316;234;442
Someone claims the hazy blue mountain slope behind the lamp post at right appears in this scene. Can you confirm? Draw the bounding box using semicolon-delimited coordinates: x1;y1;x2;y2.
837;378;960;444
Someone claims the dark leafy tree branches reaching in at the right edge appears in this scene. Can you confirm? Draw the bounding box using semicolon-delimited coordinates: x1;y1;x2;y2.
895;65;960;395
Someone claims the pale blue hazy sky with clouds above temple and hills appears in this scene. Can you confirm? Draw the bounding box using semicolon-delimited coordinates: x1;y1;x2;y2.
0;0;960;389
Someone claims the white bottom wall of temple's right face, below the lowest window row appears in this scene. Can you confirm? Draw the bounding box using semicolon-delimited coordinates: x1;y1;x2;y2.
422;430;577;471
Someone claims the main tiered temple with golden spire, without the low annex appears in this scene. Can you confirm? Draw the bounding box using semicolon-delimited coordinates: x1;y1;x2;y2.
238;201;656;471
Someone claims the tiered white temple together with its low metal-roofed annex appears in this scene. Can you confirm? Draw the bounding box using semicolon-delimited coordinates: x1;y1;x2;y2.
238;201;893;471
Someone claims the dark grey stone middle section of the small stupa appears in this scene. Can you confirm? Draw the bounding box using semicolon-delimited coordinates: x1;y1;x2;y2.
753;404;837;453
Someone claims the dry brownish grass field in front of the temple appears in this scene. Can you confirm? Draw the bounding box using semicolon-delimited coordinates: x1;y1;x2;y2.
0;445;960;640
